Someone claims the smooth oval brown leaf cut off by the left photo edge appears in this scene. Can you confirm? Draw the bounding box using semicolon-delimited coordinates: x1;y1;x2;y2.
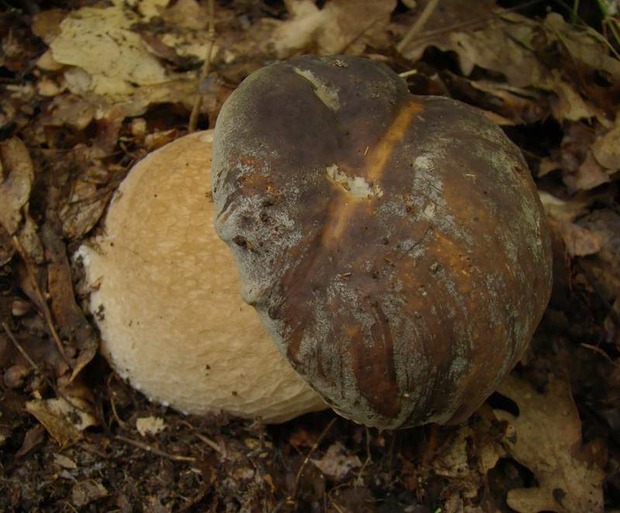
0;137;34;235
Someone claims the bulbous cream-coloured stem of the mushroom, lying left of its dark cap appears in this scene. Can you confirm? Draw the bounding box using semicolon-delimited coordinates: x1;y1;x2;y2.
78;131;326;423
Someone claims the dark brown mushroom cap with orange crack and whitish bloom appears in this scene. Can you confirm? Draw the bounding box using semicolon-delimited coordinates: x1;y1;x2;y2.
213;56;551;428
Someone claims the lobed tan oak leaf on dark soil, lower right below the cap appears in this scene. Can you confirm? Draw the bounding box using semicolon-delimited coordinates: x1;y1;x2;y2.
494;376;605;513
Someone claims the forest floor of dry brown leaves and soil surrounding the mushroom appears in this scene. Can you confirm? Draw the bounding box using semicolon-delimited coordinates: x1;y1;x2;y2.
0;0;620;513
